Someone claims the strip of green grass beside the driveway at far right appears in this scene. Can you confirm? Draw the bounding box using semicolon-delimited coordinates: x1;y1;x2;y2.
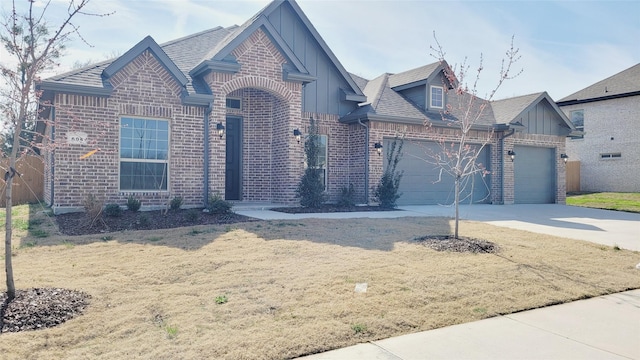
567;192;640;213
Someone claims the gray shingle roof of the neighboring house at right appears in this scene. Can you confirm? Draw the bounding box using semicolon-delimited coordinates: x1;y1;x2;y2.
558;63;640;103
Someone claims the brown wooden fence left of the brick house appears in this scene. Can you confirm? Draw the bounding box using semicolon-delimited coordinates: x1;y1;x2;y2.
0;156;44;207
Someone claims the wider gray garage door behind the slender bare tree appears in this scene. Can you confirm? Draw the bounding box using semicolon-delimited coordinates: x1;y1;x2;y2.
384;140;491;205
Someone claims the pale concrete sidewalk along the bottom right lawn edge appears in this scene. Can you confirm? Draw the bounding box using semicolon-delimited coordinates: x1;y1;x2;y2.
299;290;640;360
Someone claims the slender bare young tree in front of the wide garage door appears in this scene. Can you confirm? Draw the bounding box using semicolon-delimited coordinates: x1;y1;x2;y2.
424;32;522;239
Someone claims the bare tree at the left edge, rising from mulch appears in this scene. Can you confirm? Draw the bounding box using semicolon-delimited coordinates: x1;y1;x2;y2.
0;0;110;301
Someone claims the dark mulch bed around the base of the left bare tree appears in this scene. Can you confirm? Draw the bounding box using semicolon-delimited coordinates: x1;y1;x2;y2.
0;288;91;333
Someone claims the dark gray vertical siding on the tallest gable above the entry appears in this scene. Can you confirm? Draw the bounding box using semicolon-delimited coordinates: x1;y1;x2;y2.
269;3;357;115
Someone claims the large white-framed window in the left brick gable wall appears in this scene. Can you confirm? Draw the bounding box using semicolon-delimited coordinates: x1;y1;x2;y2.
120;117;169;191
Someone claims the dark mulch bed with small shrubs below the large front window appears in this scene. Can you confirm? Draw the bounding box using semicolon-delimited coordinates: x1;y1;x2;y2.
55;209;256;235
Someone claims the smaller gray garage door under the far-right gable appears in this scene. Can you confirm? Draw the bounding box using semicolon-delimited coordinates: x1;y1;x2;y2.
513;146;556;204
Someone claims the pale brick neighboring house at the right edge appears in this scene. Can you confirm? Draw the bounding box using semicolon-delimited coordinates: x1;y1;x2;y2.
557;64;640;192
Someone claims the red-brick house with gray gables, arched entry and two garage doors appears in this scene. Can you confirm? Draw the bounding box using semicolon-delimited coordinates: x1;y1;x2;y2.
39;0;575;212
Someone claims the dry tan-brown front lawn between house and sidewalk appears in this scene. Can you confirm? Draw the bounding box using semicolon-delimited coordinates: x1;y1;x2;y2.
0;210;640;359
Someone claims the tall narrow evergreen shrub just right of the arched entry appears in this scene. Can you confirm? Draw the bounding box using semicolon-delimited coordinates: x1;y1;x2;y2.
296;118;326;208
